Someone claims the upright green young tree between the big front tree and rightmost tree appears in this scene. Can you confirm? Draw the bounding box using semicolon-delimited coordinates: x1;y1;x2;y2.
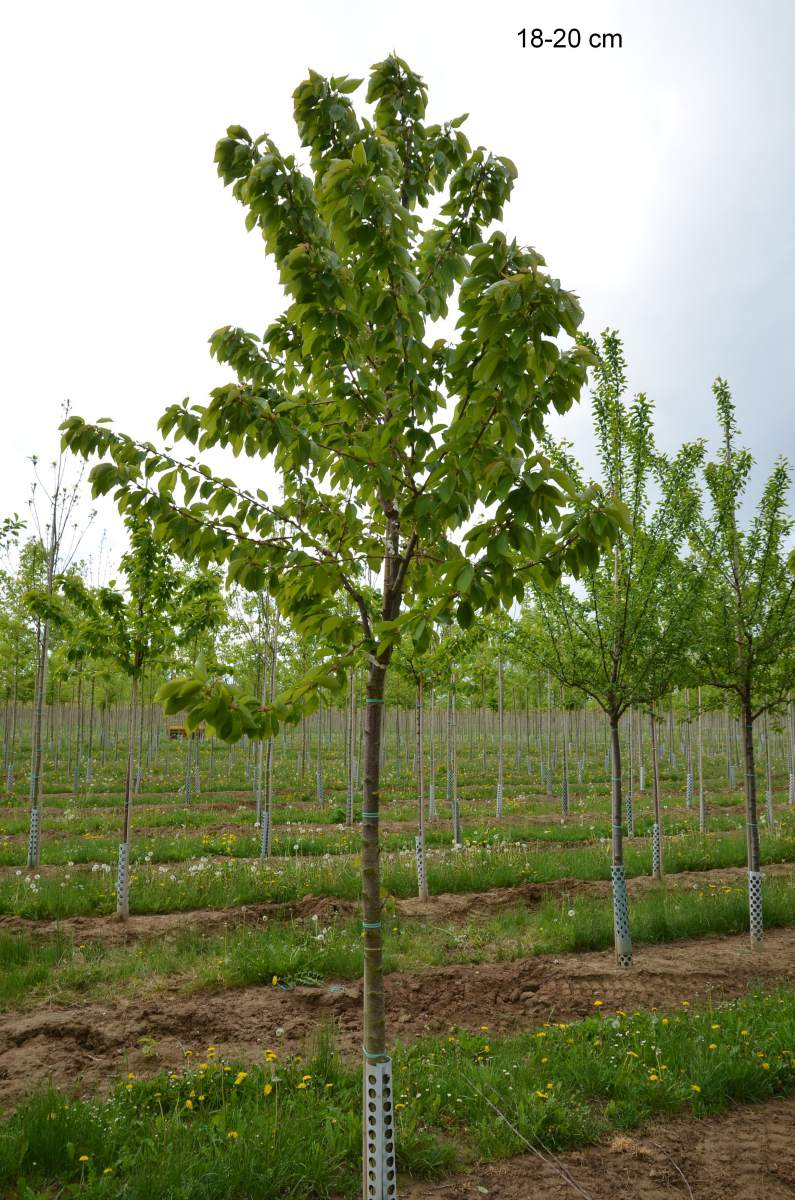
527;331;703;966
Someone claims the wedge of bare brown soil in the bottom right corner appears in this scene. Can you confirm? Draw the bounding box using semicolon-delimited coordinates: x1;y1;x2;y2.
400;1099;795;1200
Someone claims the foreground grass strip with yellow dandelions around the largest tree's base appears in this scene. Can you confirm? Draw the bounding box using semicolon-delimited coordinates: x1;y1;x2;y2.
0;990;795;1200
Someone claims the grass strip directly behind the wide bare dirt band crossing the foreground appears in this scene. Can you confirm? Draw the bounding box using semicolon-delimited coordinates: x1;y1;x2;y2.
0;877;795;1008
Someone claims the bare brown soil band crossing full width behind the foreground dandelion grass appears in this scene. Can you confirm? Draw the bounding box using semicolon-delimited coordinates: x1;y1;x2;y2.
0;929;795;1104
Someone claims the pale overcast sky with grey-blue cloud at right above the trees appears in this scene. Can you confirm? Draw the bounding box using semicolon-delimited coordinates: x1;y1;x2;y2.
0;0;795;566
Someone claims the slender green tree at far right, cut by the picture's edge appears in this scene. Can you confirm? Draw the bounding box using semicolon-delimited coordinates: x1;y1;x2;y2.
692;379;795;944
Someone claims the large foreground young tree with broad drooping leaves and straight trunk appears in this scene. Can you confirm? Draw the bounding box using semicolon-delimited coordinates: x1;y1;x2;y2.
64;55;621;1196
